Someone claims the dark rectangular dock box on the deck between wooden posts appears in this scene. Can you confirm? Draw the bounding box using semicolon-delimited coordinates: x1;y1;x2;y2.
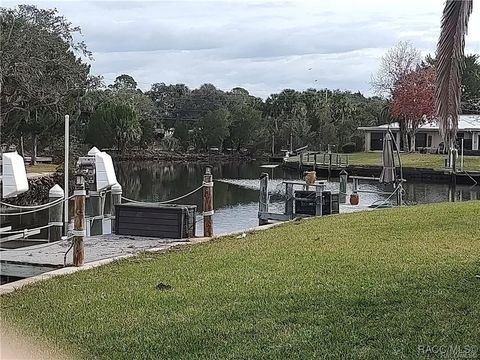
114;203;197;239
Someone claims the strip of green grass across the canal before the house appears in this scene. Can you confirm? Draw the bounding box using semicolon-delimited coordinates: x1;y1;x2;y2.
298;152;480;170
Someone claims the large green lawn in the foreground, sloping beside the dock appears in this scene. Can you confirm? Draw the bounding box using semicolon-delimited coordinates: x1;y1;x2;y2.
1;201;480;359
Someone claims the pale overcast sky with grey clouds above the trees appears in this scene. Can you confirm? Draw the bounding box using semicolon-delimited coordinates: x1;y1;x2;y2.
2;0;480;97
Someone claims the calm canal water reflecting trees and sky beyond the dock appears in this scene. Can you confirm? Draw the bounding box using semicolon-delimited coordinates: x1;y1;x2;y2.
115;161;480;235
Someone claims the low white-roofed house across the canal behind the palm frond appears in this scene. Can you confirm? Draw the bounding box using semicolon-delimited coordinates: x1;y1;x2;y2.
358;115;480;152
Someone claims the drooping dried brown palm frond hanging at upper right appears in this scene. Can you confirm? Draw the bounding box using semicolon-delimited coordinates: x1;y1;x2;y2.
435;0;473;148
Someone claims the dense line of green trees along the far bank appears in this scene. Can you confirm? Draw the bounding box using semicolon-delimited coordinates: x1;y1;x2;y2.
0;5;480;162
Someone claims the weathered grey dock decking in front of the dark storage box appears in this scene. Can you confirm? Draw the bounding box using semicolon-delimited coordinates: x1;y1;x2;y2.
0;234;194;278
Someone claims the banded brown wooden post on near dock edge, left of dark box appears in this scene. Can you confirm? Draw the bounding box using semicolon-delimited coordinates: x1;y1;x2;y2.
73;174;86;266
